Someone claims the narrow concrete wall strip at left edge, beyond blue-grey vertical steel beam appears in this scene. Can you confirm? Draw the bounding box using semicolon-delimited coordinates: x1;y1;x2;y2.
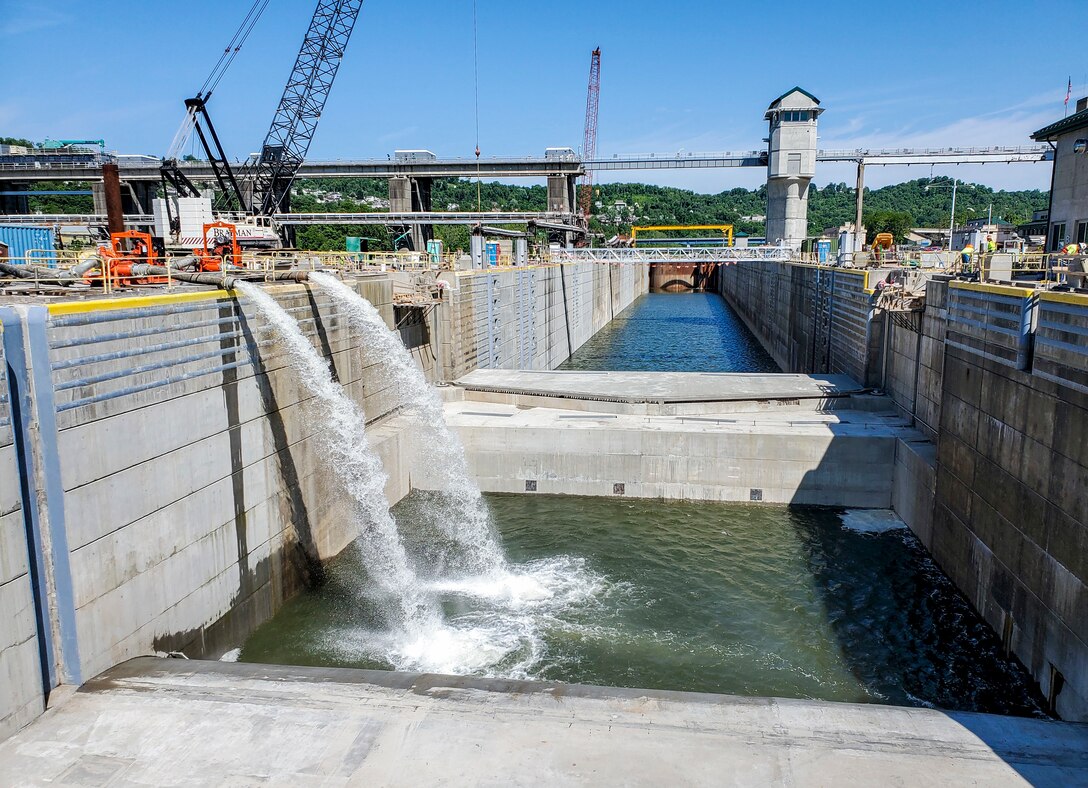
0;329;46;739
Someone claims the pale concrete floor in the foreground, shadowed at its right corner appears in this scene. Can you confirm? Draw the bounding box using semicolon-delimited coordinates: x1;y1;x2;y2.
0;657;1088;788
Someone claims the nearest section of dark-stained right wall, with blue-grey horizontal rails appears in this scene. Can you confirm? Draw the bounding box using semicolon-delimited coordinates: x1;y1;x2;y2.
929;284;1088;721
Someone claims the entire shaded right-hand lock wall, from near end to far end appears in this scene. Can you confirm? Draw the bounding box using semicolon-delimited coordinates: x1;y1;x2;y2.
722;263;1088;721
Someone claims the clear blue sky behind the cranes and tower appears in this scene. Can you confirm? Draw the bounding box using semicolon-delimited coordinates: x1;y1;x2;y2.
0;0;1088;192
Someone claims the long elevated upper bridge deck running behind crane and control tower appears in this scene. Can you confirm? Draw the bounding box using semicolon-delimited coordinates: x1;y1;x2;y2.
0;145;1053;182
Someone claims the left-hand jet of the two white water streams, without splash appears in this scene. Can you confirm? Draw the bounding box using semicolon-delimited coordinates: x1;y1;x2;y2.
236;282;441;632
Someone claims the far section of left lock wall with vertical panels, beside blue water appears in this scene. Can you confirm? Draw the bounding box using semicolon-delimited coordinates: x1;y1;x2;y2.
431;262;650;380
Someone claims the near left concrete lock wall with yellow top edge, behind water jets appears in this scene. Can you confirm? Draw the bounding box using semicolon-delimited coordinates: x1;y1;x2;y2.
0;279;419;740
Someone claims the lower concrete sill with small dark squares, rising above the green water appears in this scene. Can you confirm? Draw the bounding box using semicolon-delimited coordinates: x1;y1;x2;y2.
437;398;922;508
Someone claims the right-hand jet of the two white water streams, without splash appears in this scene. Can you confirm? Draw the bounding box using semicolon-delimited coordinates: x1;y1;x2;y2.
310;273;506;577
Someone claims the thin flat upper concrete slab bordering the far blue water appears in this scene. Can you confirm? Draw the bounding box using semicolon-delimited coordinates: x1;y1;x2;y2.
457;369;864;403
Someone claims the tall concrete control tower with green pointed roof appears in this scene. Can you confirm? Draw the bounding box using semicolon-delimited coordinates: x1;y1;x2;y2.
764;87;824;247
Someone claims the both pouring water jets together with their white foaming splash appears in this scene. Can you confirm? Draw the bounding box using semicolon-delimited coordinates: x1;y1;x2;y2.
237;273;603;677
